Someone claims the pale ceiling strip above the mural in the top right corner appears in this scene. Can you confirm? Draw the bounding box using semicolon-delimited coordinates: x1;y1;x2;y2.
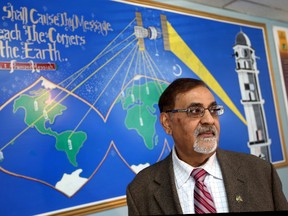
178;0;288;23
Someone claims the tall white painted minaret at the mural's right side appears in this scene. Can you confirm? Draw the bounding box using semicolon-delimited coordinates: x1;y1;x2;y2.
233;31;271;161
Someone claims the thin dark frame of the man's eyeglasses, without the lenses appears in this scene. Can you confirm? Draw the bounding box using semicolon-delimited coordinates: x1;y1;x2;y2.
164;104;224;118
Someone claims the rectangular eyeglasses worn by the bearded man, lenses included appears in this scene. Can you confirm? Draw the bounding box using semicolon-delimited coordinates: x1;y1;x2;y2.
165;105;224;118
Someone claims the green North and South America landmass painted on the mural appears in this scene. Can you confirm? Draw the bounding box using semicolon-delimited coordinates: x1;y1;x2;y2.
13;89;87;166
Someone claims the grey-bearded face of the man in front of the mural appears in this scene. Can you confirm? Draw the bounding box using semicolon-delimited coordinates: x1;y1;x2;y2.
161;86;220;165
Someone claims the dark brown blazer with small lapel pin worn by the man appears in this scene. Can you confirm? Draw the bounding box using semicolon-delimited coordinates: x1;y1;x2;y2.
126;149;288;216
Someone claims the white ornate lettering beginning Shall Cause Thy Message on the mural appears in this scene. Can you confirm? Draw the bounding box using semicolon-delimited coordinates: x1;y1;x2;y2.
0;3;113;61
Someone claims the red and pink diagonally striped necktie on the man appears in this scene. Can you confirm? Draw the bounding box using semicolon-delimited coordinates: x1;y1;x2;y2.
191;168;216;214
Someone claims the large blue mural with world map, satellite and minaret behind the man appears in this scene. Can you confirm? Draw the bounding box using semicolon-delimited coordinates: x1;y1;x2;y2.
0;0;287;216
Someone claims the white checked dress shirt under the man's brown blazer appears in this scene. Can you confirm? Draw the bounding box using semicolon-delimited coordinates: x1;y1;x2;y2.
172;147;228;214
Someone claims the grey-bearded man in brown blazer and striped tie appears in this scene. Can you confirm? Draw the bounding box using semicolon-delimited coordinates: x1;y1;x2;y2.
126;78;288;216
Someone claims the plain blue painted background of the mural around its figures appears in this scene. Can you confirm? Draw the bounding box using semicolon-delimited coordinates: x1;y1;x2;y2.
0;0;283;215
